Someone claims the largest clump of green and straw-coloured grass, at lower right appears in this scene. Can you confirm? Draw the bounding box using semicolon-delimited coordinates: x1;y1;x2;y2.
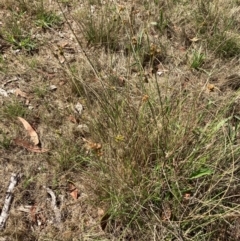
86;80;240;240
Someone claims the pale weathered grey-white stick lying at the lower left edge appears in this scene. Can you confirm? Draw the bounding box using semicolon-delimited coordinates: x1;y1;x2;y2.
0;173;20;231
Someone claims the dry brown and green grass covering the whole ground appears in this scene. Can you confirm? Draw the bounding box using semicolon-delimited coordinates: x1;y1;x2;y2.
0;0;240;241
